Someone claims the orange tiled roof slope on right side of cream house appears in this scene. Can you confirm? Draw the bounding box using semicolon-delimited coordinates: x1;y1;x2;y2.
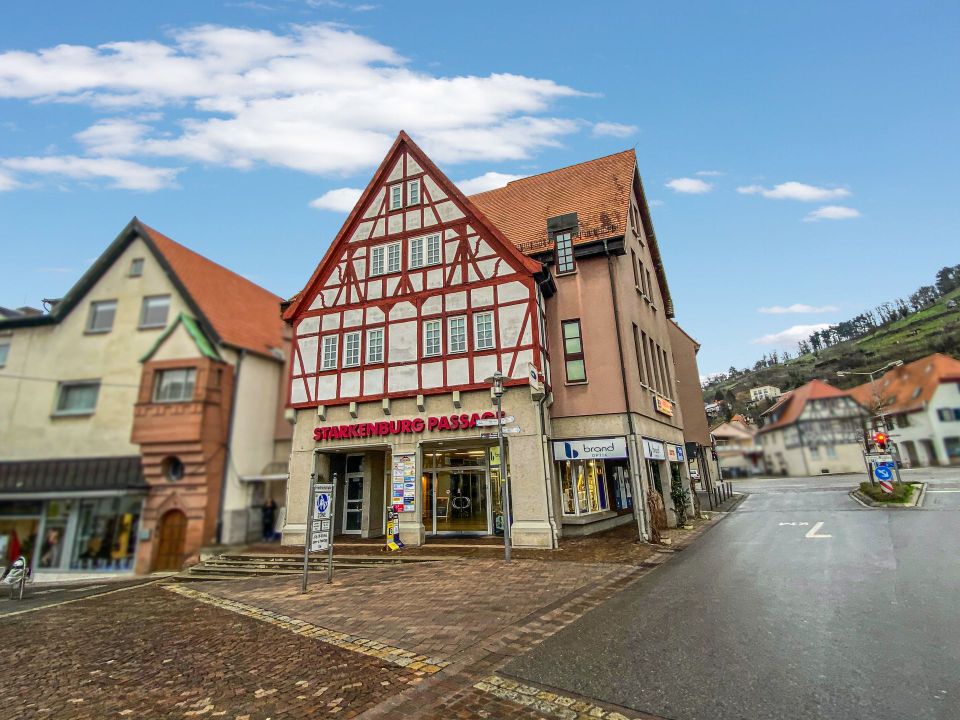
138;222;285;355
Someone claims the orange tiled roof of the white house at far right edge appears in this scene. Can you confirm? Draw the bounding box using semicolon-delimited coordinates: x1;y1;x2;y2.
850;353;960;413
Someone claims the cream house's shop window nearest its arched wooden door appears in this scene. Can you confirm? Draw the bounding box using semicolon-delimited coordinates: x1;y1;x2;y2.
70;497;142;571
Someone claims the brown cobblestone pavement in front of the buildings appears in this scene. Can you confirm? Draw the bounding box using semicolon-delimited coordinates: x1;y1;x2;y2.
0;521;712;720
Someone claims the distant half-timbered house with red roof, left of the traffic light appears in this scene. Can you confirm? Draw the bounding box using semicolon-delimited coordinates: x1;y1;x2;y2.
757;380;868;476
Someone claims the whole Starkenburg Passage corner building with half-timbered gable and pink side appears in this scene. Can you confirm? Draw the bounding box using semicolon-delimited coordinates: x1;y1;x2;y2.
283;133;689;548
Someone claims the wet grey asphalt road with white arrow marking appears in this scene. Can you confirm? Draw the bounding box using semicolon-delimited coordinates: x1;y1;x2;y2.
505;469;960;720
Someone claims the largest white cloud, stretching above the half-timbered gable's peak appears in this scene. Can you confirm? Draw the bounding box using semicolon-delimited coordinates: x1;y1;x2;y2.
0;26;585;186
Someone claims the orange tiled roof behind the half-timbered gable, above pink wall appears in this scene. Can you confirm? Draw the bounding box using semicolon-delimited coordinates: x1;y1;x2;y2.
470;150;637;253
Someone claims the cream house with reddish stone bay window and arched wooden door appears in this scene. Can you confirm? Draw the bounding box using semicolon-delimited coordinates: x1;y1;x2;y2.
0;218;290;573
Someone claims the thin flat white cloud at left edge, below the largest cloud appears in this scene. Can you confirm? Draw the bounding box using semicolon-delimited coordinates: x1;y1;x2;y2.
0;155;181;191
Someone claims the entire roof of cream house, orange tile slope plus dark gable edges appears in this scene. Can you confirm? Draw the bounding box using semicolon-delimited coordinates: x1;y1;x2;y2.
0;218;286;357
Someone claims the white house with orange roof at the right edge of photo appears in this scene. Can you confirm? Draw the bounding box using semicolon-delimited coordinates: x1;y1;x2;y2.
850;353;960;467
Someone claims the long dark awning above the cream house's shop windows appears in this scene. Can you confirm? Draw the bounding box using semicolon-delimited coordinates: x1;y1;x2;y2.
0;455;147;494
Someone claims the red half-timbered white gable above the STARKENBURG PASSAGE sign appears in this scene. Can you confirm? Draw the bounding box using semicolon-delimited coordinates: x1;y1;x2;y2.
284;132;549;408
